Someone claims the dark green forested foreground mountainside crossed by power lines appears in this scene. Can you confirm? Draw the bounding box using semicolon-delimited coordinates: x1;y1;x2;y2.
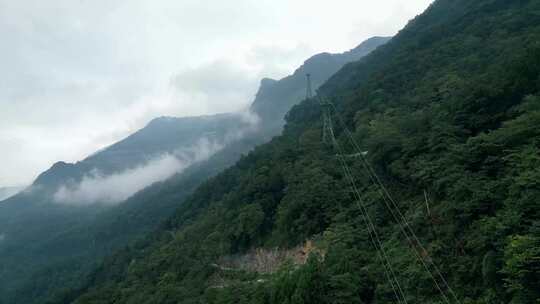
59;0;540;304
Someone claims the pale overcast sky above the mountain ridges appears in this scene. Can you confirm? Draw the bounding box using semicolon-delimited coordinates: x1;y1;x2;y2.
0;0;432;187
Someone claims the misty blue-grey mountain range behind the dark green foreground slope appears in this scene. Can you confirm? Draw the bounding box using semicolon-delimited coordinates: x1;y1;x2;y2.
0;38;388;303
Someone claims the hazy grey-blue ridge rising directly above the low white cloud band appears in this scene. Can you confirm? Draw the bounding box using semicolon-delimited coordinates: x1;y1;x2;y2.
34;114;251;187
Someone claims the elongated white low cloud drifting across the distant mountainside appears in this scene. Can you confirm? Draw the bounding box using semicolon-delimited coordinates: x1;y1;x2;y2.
54;138;223;205
